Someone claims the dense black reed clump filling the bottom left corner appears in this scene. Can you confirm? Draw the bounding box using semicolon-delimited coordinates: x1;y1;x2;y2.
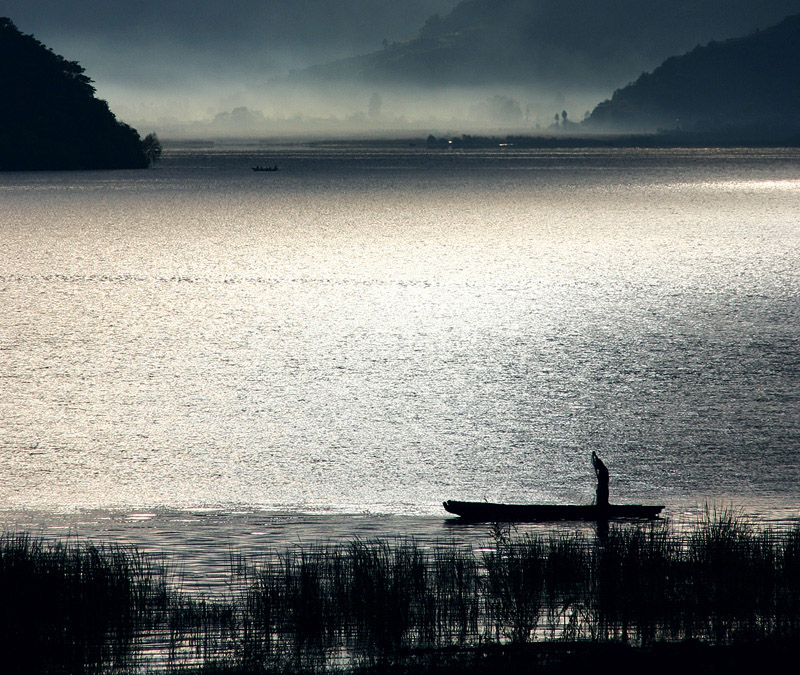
0;534;171;673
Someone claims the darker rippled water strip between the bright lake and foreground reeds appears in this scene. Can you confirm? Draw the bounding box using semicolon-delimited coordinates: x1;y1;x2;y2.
0;501;800;593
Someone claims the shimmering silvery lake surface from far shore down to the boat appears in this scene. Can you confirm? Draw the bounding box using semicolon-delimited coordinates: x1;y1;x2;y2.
0;145;800;564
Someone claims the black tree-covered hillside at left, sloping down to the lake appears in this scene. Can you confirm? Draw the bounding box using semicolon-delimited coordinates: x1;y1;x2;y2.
0;17;148;170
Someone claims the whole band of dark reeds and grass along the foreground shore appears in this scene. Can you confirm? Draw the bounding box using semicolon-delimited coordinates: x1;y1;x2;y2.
0;511;800;674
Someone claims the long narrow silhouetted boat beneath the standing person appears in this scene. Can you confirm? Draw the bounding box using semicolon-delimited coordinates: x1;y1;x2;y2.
444;499;664;522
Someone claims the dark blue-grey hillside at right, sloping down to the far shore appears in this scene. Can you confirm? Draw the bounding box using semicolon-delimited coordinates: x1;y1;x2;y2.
585;14;800;137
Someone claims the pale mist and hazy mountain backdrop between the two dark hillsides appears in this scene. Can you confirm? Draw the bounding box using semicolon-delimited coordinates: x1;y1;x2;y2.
6;0;800;137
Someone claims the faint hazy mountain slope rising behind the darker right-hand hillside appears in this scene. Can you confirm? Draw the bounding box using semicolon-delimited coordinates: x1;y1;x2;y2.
291;0;800;91
